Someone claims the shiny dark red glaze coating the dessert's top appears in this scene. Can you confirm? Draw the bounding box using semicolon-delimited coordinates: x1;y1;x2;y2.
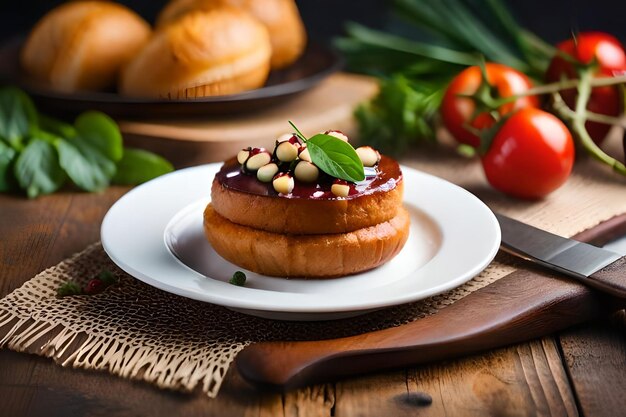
215;156;402;200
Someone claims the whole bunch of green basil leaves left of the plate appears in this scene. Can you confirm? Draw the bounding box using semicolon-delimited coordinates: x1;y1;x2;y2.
0;87;173;198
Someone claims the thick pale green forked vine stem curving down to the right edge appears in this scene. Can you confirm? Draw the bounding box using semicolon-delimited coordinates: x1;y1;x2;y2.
555;70;626;175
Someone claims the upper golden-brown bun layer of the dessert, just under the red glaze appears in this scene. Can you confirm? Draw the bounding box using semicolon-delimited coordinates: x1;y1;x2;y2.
211;179;403;234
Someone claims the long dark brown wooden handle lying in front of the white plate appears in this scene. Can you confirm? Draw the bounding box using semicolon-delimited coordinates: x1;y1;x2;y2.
237;271;624;390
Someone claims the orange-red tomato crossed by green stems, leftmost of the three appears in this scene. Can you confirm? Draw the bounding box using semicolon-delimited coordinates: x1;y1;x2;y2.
441;63;539;147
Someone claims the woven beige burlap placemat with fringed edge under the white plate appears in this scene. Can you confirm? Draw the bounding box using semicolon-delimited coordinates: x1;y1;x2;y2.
0;149;626;397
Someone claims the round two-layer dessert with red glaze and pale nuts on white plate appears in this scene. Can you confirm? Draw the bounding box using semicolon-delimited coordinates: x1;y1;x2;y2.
204;131;410;278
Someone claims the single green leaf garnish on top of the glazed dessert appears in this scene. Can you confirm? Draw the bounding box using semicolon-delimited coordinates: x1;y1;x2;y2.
306;134;365;182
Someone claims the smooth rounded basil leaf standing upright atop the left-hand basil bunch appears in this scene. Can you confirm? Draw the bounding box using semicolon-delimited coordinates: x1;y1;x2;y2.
74;111;124;162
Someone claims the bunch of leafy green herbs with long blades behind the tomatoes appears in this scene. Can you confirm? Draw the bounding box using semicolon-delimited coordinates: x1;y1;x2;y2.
335;0;555;155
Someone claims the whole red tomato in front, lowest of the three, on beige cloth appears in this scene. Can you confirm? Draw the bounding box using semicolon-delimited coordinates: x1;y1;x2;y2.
482;107;574;199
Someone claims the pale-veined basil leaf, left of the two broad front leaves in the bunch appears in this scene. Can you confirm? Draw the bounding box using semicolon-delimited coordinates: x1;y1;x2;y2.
14;139;66;198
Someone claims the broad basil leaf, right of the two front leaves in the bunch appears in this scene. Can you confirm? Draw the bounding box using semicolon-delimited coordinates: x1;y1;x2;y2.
56;137;116;191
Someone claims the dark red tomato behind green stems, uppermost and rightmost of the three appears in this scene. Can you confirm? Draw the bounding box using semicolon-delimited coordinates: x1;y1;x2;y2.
546;32;626;143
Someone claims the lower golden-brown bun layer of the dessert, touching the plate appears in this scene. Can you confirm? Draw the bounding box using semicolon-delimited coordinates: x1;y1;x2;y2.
204;204;410;278
